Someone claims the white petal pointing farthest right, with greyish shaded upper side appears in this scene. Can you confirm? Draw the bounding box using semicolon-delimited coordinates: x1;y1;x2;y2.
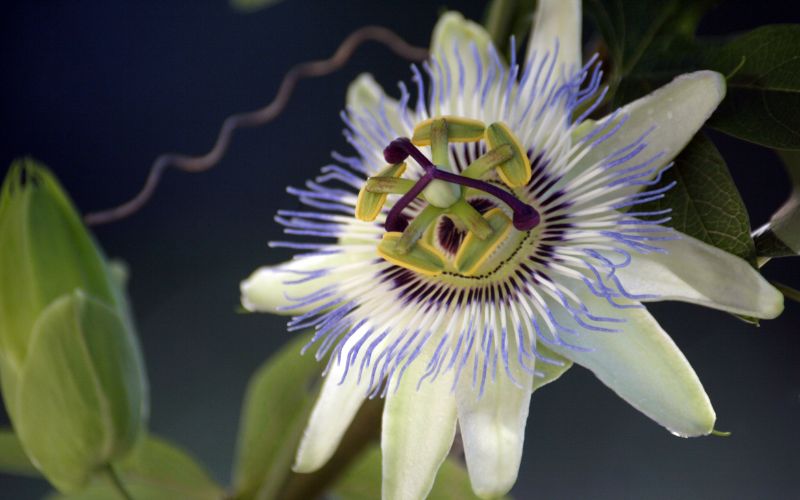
616;229;783;318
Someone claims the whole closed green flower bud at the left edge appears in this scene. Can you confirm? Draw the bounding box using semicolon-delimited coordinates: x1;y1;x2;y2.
0;159;148;492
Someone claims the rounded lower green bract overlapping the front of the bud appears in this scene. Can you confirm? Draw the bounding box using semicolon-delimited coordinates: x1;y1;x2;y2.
13;290;147;492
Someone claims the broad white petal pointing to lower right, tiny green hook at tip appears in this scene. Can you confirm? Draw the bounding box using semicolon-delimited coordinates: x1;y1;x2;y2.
549;291;716;437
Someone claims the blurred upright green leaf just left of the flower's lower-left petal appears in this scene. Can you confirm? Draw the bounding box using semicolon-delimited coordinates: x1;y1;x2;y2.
228;335;324;498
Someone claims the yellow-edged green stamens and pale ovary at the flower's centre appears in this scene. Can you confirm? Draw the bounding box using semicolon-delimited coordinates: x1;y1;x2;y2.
356;116;540;277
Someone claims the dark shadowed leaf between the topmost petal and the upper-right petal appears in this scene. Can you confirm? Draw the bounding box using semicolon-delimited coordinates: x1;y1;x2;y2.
584;0;718;108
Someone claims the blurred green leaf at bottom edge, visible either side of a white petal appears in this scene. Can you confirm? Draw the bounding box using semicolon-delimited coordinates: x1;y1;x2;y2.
331;445;490;500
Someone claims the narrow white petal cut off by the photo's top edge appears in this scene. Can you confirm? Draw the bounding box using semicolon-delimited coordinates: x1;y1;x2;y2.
526;0;582;74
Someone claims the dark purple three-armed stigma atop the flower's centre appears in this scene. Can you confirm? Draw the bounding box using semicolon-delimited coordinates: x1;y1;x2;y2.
383;137;541;231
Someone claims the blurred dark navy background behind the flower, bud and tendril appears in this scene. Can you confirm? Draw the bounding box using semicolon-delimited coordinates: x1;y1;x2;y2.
0;0;800;499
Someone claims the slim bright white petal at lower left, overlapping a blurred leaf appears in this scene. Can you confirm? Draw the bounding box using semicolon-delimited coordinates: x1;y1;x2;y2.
292;335;367;472
